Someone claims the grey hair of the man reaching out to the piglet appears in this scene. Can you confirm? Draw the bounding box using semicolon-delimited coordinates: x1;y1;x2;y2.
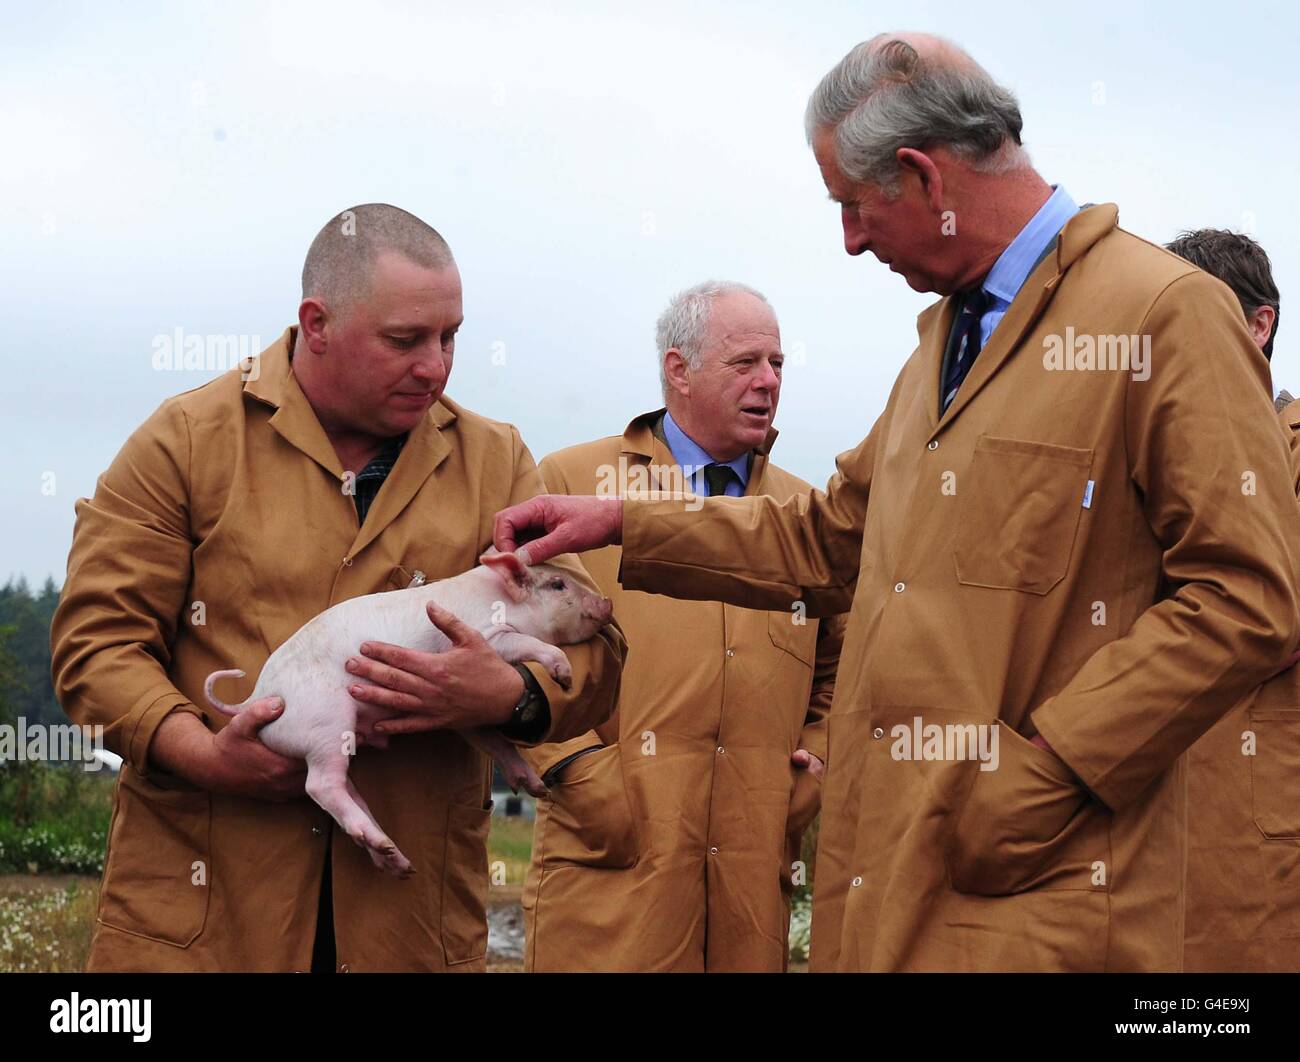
803;36;1028;198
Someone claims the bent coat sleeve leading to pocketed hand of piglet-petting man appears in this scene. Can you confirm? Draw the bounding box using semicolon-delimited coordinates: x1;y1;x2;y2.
1032;273;1300;809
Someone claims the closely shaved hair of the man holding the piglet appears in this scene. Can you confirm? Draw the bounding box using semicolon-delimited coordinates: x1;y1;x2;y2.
303;203;455;313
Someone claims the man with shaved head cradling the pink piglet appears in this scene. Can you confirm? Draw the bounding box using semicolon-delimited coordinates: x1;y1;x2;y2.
51;204;623;972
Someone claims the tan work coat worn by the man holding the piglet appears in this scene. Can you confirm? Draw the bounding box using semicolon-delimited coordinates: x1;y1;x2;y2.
51;329;623;971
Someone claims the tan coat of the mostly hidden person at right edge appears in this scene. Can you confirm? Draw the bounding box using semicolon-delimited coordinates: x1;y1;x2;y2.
1183;402;1300;974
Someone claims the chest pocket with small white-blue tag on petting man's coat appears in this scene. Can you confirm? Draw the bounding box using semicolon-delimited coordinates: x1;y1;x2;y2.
953;435;1092;594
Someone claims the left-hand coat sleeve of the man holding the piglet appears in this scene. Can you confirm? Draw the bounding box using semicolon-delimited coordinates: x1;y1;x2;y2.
49;392;203;776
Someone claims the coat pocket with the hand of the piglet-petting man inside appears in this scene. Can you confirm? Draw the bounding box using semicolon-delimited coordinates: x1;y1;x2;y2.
945;724;1110;896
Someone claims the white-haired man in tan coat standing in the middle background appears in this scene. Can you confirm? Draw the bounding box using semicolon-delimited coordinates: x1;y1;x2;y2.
524;281;841;972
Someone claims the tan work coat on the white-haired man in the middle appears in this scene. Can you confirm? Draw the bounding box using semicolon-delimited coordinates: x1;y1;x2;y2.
524;409;842;971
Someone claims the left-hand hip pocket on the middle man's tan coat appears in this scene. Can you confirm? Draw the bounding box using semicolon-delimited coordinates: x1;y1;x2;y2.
538;745;637;870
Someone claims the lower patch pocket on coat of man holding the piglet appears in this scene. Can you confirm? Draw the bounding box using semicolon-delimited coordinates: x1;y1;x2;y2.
99;766;212;948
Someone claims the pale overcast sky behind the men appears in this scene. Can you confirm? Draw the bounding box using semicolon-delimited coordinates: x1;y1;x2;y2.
0;0;1300;582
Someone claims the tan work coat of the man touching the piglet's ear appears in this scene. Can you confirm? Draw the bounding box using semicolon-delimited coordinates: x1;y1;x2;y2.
621;204;1300;970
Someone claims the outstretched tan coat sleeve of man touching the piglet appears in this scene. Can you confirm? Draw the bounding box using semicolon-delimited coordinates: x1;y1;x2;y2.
619;417;884;616
